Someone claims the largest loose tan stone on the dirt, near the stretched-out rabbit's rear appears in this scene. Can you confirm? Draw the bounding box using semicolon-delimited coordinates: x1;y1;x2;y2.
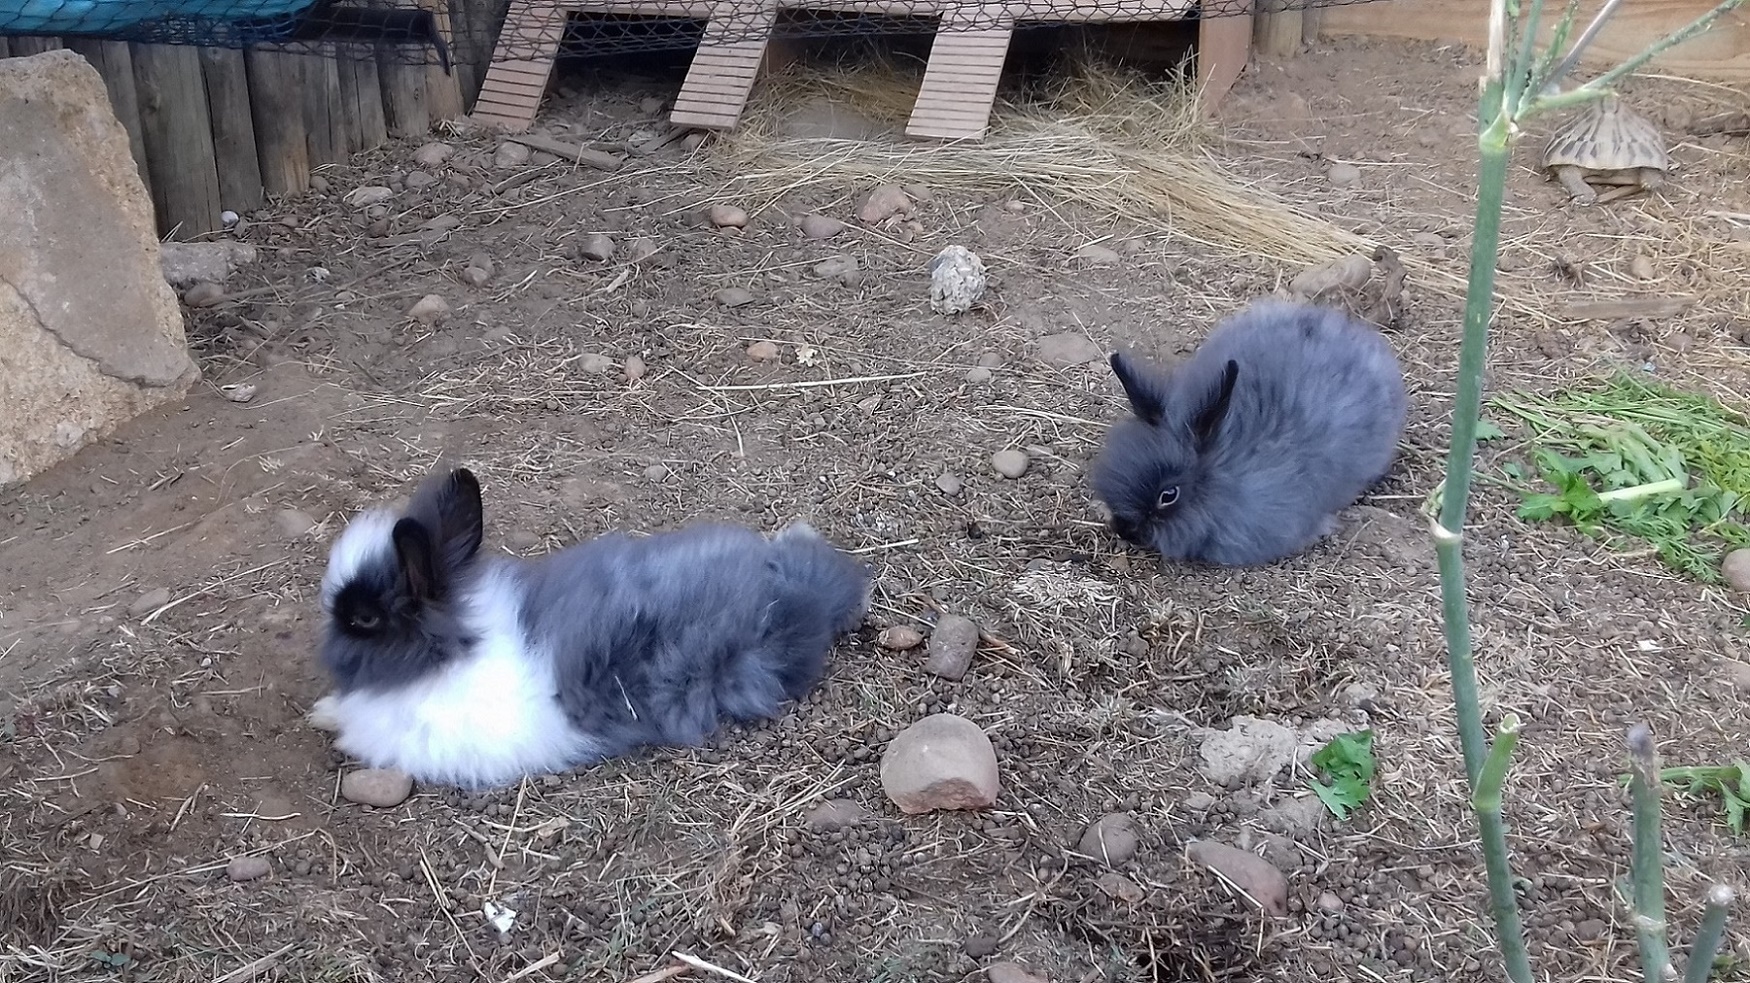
880;714;1001;815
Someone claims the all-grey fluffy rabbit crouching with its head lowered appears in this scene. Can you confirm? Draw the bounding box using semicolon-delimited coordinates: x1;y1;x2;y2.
1090;293;1407;567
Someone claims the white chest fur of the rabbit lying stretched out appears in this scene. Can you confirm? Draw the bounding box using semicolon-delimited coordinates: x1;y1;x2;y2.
310;572;600;789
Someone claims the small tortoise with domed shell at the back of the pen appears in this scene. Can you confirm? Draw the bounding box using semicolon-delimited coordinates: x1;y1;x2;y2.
1544;94;1670;205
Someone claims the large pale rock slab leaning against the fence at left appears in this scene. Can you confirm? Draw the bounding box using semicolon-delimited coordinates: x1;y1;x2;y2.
0;51;200;485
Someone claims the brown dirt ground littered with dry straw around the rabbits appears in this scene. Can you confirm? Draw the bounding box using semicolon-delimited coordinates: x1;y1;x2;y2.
0;20;1750;983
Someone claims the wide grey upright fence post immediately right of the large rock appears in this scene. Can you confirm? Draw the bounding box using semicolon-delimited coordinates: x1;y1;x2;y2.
131;44;224;238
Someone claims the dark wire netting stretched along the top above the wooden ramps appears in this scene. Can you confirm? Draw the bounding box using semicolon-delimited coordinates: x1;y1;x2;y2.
0;0;1372;68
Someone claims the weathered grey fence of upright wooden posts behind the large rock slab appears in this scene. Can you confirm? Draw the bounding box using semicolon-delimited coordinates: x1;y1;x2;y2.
0;0;495;238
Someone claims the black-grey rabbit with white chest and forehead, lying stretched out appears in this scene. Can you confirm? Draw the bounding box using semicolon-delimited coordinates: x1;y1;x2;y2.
310;469;870;789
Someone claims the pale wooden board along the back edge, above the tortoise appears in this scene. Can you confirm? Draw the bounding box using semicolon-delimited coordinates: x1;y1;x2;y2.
1318;0;1750;82
